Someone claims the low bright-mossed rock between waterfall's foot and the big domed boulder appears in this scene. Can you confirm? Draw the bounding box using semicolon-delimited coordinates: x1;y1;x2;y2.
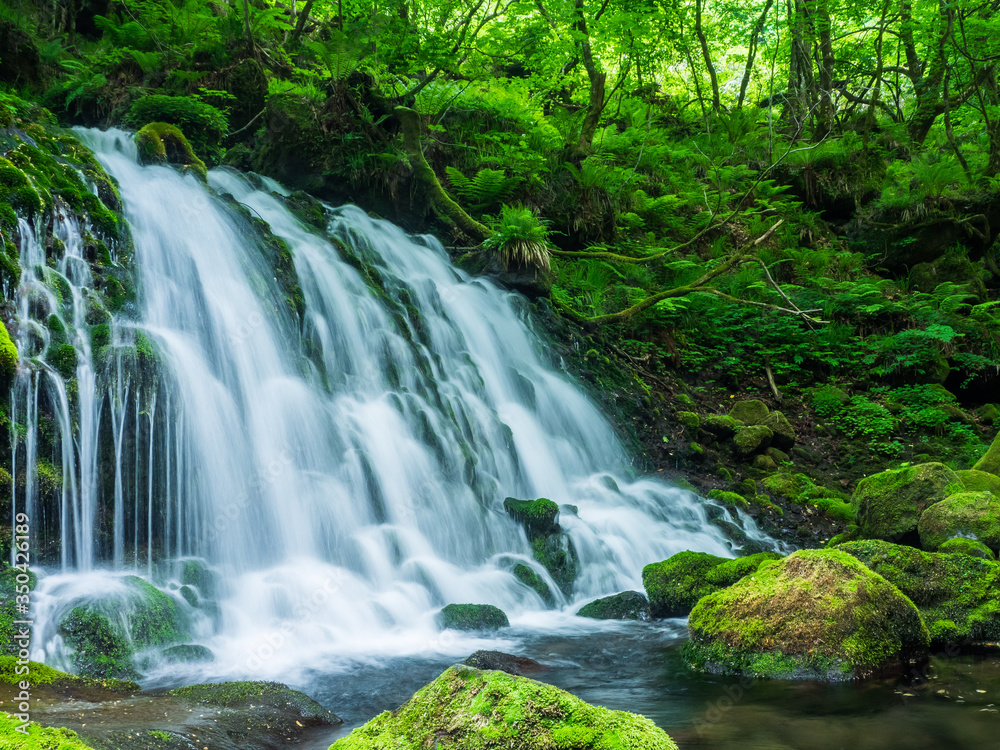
642;551;781;617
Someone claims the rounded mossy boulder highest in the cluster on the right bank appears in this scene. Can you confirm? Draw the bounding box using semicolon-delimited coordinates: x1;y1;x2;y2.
851;463;962;540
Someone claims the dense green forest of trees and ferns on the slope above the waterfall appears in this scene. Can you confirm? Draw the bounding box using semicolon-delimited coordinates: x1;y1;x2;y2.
0;0;1000;508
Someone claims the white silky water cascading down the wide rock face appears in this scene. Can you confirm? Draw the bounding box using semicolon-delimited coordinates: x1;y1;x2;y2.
14;131;776;681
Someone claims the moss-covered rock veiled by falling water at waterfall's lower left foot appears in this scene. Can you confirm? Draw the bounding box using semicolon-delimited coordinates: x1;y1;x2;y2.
59;576;189;679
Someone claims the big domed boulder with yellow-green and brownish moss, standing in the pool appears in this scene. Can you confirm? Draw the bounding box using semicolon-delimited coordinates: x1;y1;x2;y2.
684;549;929;680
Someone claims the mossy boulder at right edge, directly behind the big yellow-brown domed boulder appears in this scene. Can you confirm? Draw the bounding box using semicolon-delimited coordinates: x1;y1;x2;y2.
837;540;1000;645
